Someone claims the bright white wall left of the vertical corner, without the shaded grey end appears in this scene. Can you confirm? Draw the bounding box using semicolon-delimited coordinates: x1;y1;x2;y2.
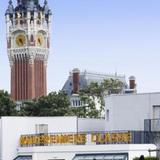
2;117;76;160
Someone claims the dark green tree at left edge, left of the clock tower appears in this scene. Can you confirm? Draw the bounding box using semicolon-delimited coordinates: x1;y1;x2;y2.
0;91;18;116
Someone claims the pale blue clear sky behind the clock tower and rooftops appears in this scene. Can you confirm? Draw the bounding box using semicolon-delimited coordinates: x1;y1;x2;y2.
0;0;160;92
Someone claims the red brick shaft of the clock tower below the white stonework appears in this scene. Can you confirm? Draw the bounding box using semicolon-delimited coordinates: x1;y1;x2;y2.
11;58;46;101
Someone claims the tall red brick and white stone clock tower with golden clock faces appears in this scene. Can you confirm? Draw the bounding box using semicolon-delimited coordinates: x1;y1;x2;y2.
5;0;51;101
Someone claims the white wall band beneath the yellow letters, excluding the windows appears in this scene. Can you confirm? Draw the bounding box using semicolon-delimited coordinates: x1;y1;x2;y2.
18;144;156;160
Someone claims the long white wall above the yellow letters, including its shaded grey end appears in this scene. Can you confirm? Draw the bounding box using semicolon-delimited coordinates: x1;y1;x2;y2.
0;117;105;160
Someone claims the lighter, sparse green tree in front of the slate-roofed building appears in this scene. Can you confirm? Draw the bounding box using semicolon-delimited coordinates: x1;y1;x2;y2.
73;79;124;118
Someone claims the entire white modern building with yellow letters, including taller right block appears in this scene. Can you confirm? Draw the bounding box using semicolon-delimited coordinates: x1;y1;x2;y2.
0;93;160;160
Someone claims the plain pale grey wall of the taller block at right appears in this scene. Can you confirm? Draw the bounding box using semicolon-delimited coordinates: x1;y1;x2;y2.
105;93;160;130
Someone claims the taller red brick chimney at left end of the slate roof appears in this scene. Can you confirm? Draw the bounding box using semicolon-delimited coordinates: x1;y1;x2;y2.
72;68;80;94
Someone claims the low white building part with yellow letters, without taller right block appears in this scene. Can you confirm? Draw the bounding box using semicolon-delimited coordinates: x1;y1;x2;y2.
0;117;156;160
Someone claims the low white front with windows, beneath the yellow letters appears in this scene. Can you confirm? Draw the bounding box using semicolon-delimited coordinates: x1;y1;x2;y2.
16;144;156;160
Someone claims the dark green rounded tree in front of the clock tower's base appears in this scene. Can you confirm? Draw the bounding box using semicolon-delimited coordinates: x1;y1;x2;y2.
21;91;70;116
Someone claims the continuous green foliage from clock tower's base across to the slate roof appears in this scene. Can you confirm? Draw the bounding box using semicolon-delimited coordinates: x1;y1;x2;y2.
20;79;123;118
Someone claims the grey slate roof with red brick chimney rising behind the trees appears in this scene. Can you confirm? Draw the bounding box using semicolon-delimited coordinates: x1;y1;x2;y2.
62;68;128;96
